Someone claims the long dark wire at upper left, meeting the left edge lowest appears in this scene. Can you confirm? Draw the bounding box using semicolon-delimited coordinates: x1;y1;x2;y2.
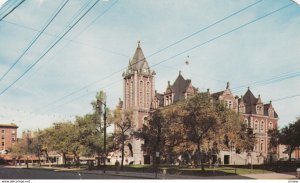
0;0;100;96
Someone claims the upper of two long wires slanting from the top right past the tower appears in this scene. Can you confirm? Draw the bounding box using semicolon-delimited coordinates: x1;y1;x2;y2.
37;0;262;111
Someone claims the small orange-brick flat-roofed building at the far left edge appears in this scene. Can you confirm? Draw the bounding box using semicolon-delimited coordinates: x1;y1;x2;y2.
0;123;18;150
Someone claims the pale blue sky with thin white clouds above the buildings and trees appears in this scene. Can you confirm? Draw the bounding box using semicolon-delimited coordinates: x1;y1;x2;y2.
0;0;300;132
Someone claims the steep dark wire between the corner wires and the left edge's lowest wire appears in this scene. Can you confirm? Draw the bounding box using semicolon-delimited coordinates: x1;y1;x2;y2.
0;0;69;82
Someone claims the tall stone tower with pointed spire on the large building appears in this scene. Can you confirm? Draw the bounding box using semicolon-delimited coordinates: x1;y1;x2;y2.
123;42;155;164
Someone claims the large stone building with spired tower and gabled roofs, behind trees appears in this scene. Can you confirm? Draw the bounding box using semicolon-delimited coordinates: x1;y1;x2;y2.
122;43;278;164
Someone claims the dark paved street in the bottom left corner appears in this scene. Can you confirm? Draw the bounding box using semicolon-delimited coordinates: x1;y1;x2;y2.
0;167;139;179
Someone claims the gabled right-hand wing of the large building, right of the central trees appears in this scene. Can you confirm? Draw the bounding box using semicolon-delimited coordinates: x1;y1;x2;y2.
211;83;278;164
